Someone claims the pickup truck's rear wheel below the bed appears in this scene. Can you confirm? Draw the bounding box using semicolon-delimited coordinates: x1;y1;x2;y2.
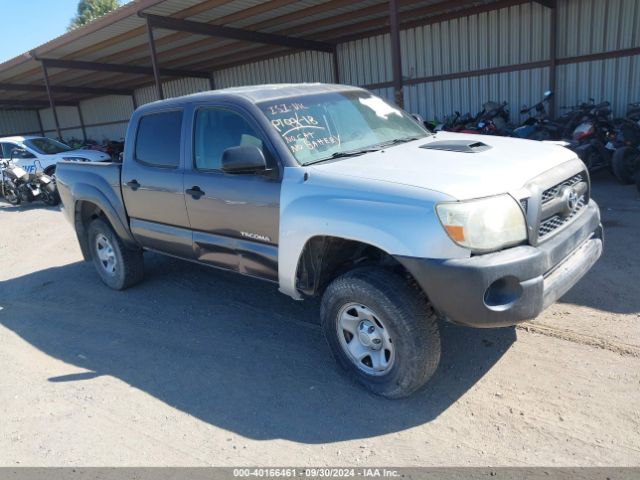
87;218;144;290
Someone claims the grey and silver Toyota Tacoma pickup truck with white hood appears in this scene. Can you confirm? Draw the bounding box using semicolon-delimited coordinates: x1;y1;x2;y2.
57;84;603;398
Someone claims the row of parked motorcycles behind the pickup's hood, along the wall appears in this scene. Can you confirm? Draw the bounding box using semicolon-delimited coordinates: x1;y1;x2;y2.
425;92;640;191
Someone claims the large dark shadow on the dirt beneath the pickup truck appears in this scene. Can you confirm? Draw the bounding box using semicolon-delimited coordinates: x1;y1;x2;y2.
0;254;516;443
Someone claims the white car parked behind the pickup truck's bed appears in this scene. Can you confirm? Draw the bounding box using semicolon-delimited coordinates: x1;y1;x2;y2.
0;135;111;175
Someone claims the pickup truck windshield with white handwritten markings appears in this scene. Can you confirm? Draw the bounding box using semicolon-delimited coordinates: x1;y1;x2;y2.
258;91;429;165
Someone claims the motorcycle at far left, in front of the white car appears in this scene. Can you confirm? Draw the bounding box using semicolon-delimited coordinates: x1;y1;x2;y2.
0;149;60;206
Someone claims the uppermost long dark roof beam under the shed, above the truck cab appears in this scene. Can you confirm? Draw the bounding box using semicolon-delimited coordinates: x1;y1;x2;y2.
138;12;334;53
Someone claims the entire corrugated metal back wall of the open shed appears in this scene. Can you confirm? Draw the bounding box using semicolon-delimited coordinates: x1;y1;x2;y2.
0;0;640;141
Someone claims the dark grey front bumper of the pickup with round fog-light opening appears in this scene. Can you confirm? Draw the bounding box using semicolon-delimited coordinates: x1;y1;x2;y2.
396;201;603;328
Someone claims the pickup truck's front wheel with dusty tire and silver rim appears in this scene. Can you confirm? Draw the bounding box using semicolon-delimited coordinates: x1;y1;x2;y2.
320;267;441;398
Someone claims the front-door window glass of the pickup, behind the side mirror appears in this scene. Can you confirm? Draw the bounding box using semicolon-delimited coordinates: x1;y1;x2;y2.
194;108;273;170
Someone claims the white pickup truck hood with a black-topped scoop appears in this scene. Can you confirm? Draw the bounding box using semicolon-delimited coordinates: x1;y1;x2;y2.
312;132;576;200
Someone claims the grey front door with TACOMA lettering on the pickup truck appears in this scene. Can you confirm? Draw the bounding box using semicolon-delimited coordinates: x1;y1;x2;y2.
184;106;280;281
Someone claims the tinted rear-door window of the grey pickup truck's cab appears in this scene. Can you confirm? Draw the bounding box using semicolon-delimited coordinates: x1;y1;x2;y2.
136;110;182;167
